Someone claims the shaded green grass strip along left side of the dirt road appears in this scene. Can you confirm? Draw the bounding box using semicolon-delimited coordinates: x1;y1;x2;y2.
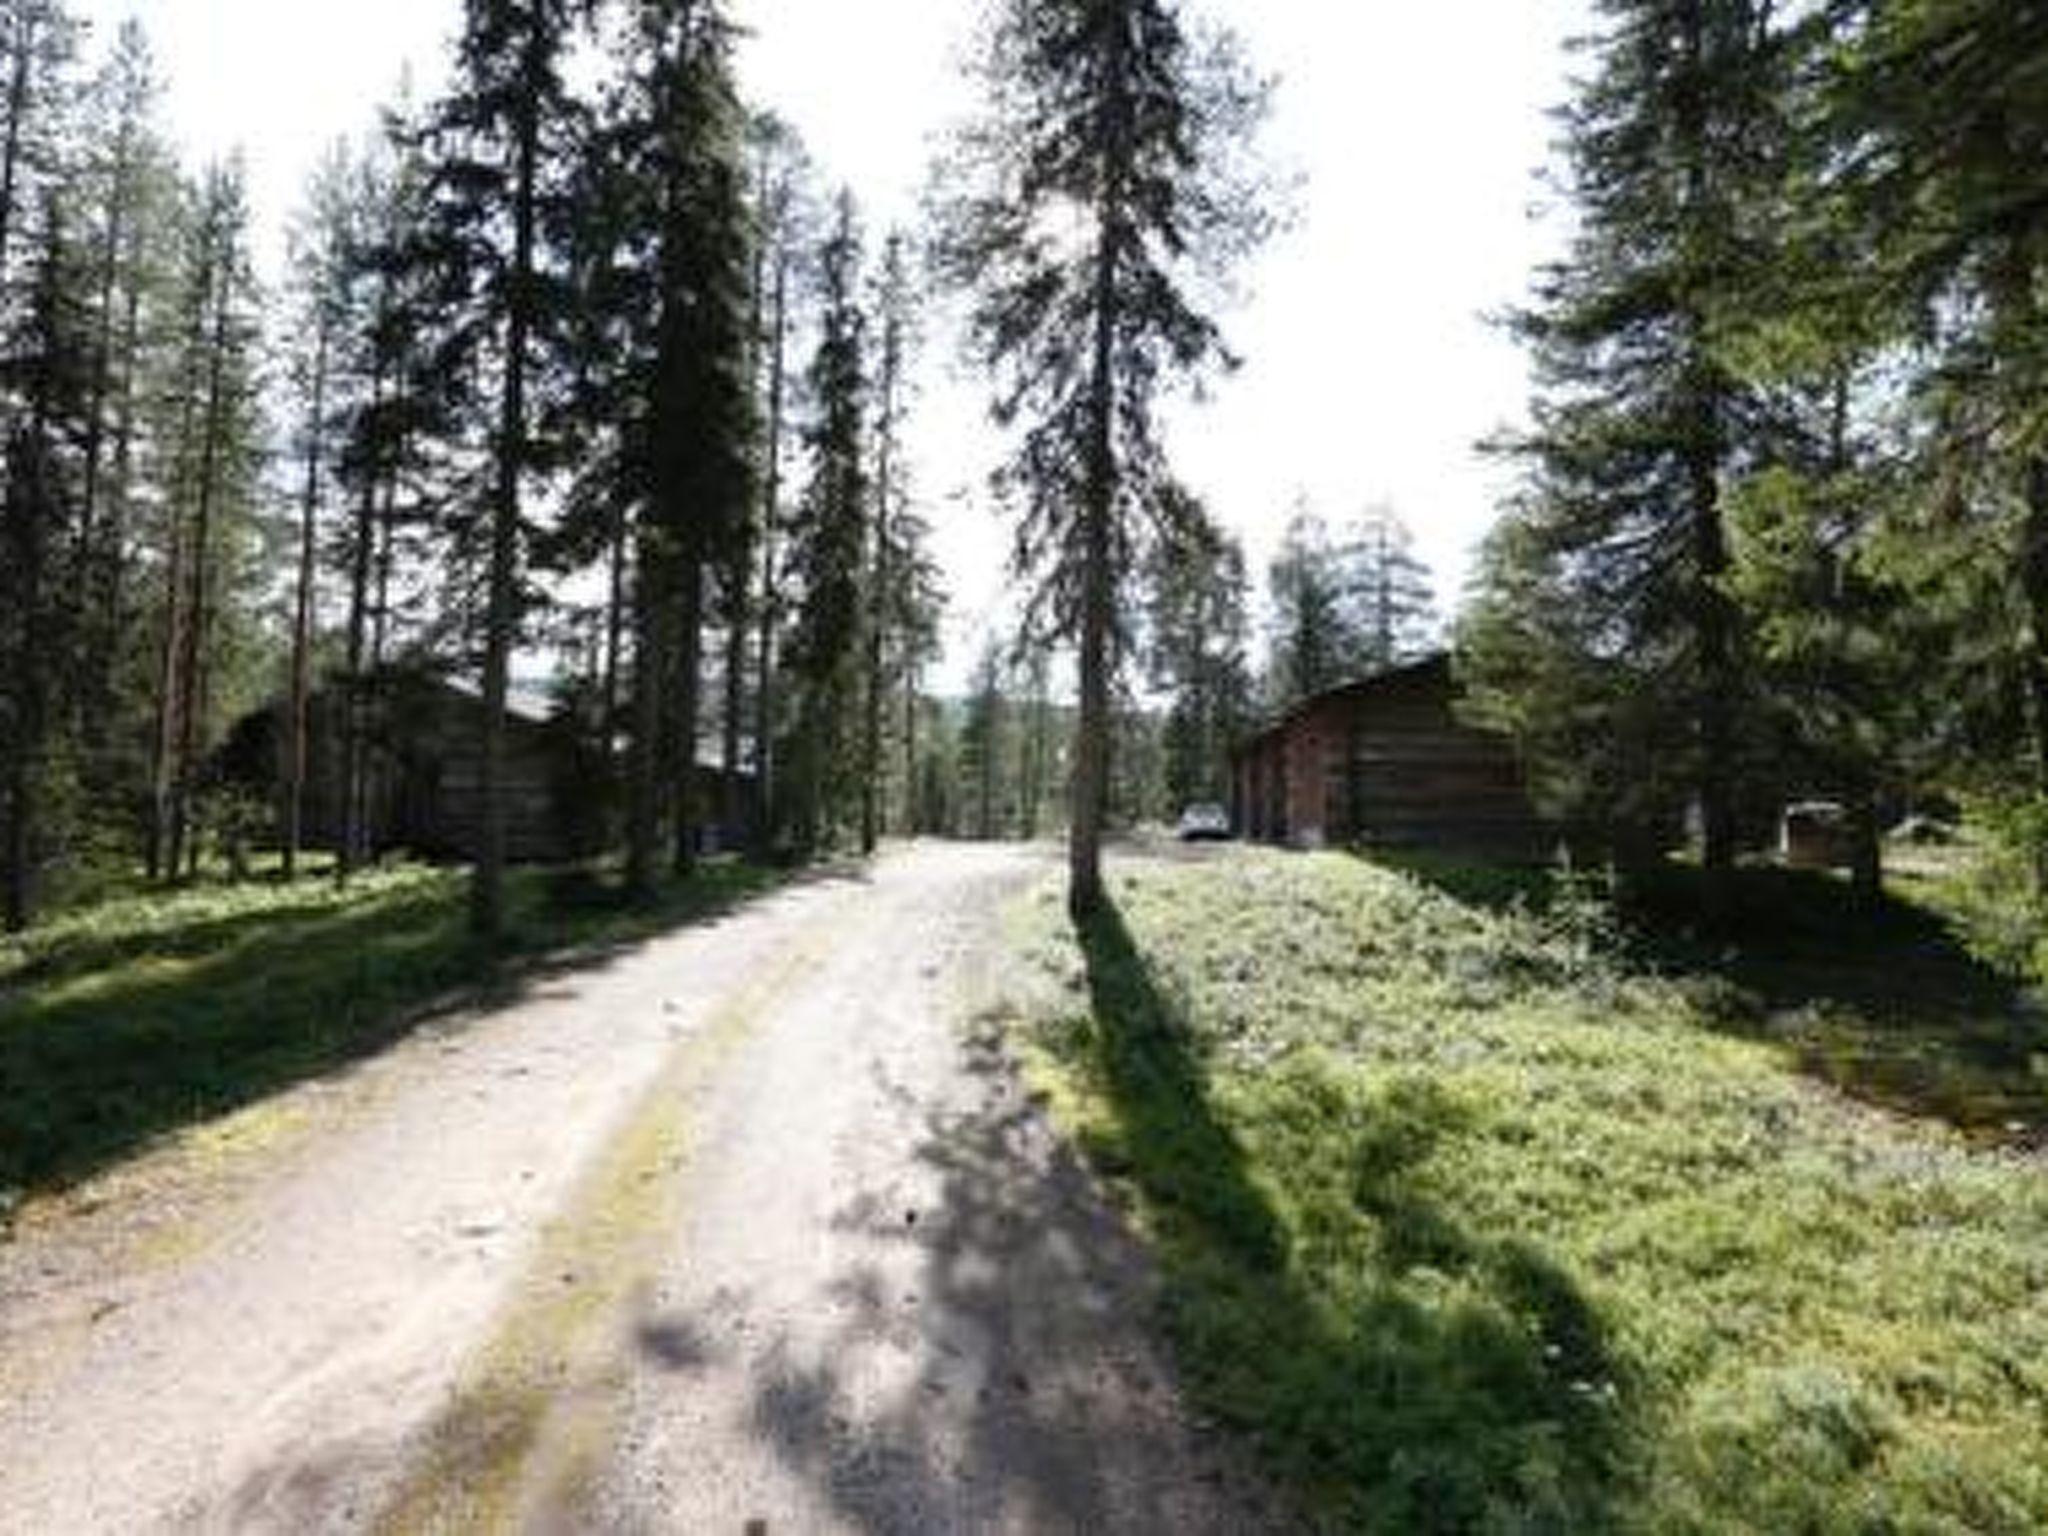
0;862;778;1198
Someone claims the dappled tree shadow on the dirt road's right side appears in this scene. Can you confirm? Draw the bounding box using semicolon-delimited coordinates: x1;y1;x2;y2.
704;1003;1300;1536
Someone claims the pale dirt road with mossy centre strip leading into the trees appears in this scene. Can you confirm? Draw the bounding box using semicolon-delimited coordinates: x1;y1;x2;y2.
0;846;1276;1536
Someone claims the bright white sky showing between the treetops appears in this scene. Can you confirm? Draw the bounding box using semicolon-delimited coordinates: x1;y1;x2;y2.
74;0;1587;684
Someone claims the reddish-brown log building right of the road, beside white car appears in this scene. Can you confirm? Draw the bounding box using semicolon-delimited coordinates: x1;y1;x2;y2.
1231;655;1554;858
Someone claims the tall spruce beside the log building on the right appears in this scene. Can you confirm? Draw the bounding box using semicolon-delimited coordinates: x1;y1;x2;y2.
1481;0;1786;913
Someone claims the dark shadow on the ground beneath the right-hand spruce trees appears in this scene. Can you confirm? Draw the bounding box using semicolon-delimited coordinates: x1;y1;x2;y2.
1374;854;2048;1143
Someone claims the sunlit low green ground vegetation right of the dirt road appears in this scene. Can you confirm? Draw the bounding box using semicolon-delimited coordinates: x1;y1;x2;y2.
1016;850;2048;1532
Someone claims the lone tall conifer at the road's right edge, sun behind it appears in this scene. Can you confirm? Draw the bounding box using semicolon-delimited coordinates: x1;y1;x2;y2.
940;0;1266;915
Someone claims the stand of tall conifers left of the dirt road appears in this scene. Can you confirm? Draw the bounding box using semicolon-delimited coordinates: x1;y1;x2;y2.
0;0;966;930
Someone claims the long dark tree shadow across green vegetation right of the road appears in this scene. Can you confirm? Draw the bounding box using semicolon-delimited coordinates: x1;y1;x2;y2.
1069;905;1632;1532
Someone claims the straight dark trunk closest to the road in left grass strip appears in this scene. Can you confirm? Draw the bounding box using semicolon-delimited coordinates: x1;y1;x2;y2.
469;83;541;940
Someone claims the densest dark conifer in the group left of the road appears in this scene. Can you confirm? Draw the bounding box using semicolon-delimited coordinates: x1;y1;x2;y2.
584;2;756;895
